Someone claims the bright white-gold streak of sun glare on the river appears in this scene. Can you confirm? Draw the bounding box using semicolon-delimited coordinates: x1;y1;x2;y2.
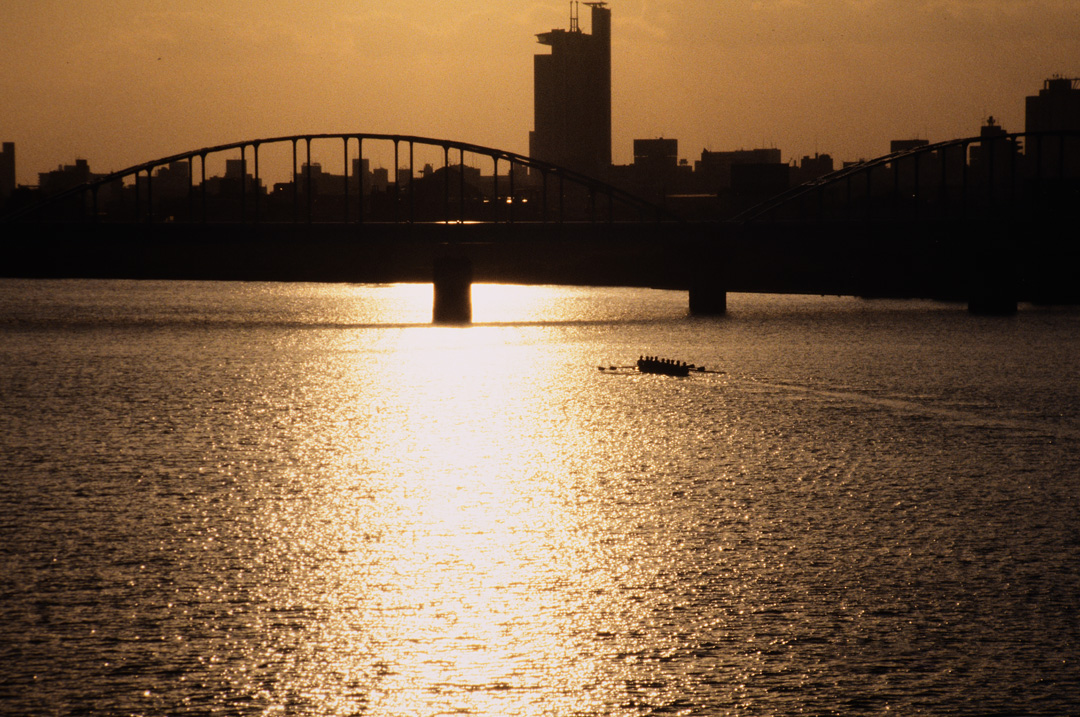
260;287;630;715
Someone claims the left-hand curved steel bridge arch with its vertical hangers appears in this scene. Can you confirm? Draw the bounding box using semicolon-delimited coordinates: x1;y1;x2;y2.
0;133;678;224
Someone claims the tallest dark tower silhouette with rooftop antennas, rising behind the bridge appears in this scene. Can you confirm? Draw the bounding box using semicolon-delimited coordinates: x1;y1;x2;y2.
529;2;611;176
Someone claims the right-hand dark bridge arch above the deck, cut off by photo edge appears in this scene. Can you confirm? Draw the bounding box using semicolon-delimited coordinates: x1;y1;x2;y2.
735;131;1080;222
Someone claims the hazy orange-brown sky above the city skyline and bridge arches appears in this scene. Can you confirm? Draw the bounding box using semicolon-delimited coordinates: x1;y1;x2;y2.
0;0;1080;184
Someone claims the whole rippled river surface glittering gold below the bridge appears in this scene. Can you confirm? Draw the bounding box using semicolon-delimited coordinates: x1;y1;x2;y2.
0;280;1080;716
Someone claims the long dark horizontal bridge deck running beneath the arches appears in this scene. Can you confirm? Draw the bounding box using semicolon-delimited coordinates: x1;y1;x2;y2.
0;220;1080;302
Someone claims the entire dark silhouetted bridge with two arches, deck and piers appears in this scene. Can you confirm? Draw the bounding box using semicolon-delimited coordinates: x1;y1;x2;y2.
0;132;1080;313
